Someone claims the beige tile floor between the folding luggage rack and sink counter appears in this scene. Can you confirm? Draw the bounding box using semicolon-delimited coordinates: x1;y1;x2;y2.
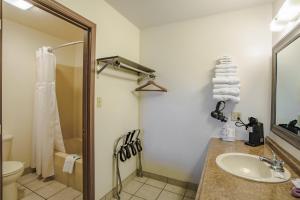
112;177;196;200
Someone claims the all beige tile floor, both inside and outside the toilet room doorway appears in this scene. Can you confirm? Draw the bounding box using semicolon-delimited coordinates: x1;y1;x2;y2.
18;174;196;200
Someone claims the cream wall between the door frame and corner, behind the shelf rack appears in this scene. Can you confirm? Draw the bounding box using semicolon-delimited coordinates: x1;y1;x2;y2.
55;0;140;199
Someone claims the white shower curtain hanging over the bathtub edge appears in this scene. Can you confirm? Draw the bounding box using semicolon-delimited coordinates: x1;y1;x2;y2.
31;47;65;178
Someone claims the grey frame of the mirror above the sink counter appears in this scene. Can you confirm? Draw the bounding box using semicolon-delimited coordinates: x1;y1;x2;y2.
271;24;300;149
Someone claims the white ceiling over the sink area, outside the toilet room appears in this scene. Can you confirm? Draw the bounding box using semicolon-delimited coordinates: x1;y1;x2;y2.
106;0;273;28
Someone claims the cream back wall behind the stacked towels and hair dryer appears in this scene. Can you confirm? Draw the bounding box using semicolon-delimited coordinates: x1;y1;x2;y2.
141;4;272;183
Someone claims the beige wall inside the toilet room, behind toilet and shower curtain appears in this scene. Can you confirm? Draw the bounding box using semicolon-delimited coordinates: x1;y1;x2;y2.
2;19;76;167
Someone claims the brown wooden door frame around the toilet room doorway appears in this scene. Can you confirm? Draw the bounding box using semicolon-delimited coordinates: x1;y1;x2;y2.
0;0;96;200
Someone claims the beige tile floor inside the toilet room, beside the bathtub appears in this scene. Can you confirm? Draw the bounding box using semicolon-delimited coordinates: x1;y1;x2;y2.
18;174;82;200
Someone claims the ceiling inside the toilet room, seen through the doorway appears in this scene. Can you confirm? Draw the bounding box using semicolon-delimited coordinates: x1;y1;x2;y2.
3;2;84;41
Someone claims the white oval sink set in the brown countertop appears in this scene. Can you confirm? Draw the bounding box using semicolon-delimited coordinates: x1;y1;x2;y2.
216;153;291;183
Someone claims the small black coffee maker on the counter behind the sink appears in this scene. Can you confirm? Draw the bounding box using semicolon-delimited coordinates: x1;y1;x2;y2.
235;117;265;147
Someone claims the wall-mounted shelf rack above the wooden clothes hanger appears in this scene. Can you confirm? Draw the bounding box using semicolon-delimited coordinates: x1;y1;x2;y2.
97;56;155;78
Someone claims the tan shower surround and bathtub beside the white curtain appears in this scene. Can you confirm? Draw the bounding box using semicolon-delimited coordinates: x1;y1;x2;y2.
54;50;83;192
